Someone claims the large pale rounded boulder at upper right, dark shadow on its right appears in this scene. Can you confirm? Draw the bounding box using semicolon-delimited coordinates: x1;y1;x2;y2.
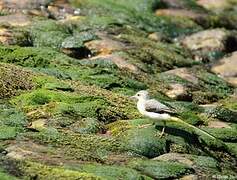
181;29;236;60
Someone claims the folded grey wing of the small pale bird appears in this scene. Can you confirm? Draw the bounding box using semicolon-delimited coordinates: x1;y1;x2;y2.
145;99;175;113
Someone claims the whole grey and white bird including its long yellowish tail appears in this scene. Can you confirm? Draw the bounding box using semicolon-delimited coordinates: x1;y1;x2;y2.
130;90;216;140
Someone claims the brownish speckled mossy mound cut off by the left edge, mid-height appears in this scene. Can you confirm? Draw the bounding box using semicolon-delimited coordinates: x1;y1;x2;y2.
0;63;35;98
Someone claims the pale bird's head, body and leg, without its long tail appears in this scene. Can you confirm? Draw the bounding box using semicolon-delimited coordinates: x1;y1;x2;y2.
130;90;177;137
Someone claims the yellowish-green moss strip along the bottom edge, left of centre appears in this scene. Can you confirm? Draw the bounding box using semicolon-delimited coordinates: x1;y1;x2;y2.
21;162;102;180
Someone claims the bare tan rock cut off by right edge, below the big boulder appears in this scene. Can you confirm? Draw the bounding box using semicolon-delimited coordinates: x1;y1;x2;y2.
211;52;237;87
